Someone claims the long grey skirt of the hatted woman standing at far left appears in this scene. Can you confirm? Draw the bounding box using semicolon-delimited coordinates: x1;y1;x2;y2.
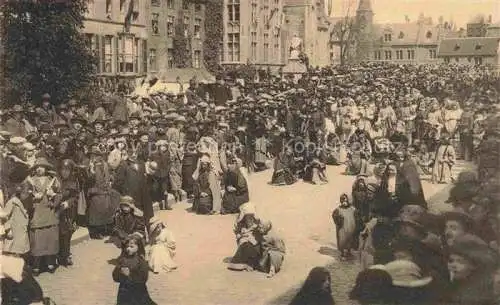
30;225;59;256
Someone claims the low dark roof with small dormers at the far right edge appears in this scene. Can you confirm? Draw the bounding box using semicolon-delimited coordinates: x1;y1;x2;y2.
437;37;500;56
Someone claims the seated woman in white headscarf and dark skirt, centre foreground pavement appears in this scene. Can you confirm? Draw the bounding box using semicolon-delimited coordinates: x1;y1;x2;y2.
228;203;261;271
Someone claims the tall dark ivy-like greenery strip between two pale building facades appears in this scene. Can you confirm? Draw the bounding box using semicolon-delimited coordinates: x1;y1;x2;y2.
203;0;224;74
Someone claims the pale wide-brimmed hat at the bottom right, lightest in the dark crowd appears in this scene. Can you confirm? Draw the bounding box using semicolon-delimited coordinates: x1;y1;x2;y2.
370;260;432;288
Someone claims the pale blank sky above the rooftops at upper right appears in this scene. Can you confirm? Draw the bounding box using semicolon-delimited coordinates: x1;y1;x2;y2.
326;0;500;27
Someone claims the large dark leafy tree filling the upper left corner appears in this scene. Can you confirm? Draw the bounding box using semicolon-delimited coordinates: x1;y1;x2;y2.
0;0;97;103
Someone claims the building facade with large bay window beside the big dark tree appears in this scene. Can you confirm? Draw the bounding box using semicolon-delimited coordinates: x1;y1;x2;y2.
83;0;149;89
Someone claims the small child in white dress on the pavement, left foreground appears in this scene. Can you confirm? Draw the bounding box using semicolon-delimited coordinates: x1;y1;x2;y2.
148;217;177;273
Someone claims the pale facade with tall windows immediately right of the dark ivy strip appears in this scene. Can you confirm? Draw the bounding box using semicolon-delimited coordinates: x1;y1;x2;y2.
221;0;283;68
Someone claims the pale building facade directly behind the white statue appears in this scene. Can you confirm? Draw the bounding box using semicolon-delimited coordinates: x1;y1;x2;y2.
283;0;331;67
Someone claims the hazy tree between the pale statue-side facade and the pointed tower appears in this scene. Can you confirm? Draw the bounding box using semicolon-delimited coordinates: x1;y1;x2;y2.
330;16;356;65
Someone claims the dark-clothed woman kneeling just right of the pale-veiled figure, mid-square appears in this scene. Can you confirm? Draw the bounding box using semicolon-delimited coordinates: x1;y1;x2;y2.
222;158;249;214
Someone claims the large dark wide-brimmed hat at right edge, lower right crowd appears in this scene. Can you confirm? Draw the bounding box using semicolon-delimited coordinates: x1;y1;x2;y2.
449;234;499;268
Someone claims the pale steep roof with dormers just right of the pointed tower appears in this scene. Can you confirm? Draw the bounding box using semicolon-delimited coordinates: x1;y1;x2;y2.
373;22;450;45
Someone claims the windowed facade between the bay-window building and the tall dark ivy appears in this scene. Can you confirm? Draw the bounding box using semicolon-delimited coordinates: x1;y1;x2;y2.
147;0;205;82
